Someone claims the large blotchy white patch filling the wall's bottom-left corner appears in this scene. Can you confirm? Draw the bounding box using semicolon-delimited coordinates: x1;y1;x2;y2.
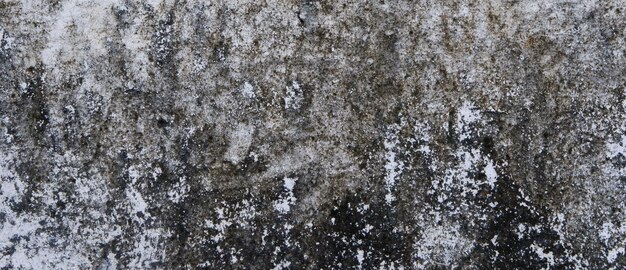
0;145;127;269
